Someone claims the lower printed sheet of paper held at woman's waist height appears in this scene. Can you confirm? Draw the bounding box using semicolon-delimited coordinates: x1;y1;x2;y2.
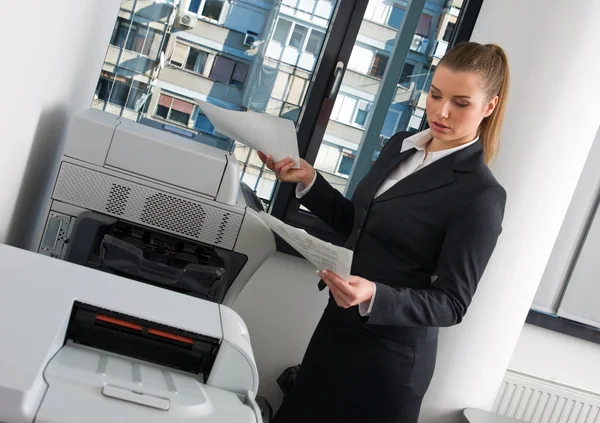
260;212;353;280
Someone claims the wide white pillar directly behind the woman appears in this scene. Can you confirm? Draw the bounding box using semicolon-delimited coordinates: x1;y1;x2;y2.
421;0;600;422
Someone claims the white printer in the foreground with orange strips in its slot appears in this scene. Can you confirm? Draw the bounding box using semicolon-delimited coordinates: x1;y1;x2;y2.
0;245;262;423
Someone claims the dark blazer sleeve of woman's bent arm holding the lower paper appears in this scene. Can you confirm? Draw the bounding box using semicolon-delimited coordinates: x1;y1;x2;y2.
364;186;506;327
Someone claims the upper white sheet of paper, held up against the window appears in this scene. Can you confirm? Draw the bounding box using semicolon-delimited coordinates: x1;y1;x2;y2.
198;100;300;168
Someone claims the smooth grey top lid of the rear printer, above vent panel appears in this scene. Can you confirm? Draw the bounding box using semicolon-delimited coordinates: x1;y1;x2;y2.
64;108;239;205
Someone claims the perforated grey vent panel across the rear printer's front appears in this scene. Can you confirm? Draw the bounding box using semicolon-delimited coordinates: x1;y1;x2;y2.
52;162;244;250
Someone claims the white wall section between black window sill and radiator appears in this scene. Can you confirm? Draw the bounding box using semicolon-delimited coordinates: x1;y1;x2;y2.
510;325;600;394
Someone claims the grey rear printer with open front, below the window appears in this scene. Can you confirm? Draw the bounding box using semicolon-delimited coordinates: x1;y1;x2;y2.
34;109;275;305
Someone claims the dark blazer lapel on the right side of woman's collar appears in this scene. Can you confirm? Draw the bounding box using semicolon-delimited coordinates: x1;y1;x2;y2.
374;142;483;203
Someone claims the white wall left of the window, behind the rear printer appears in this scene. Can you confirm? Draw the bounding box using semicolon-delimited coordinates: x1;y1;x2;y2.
0;0;121;246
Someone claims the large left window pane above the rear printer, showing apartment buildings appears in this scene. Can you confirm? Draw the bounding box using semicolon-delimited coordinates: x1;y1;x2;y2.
92;0;338;204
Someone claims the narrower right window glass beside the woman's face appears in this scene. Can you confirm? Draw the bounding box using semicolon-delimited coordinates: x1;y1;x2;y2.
314;0;468;194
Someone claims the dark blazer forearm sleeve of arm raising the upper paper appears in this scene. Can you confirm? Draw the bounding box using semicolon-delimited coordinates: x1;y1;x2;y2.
300;172;354;237
